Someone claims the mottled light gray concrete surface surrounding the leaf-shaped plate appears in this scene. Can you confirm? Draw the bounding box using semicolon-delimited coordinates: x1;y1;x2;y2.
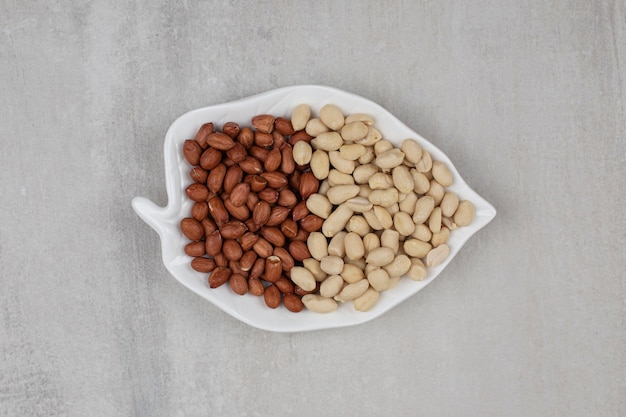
0;0;626;417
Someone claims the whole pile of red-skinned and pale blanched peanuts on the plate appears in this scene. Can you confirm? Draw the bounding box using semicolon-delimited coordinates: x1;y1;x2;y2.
181;104;475;313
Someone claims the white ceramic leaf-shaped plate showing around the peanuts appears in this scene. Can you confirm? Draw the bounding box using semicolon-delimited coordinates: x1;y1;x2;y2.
132;85;496;332
